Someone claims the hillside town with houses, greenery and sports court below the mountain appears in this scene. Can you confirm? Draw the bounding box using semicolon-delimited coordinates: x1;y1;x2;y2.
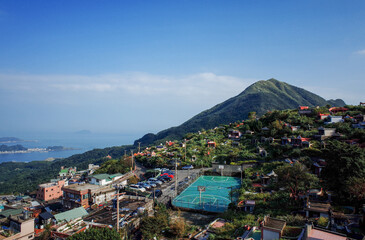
0;104;365;240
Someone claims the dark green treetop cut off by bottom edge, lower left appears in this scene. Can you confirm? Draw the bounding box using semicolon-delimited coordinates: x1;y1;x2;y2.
68;228;121;240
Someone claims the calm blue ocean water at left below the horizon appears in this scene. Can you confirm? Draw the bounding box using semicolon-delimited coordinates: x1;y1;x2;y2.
0;133;142;163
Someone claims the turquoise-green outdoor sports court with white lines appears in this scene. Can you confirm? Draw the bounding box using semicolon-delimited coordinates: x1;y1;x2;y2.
172;176;241;212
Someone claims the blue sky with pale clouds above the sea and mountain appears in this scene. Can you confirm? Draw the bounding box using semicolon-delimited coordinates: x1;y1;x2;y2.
0;0;365;136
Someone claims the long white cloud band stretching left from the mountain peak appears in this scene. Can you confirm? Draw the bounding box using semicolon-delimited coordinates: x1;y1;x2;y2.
0;72;255;97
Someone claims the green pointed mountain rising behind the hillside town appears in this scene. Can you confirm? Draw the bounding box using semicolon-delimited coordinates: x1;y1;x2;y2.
134;79;345;145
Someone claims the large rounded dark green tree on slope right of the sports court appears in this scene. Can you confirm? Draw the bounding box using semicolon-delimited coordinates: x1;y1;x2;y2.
275;162;318;199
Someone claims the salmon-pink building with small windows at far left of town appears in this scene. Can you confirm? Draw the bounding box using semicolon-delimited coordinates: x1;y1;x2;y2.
37;180;65;202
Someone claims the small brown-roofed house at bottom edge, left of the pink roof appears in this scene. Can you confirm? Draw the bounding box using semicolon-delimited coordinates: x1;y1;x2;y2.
261;216;286;240
